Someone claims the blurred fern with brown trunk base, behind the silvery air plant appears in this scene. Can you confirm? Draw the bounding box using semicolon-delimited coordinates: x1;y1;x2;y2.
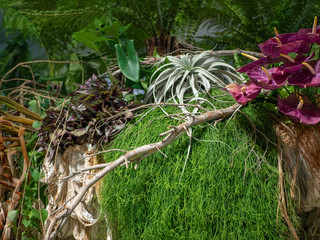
110;0;196;56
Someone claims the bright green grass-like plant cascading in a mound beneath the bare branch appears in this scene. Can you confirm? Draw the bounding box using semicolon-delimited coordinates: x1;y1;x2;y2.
100;89;298;239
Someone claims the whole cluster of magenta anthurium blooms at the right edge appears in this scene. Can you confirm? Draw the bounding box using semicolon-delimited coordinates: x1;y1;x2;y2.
225;17;320;124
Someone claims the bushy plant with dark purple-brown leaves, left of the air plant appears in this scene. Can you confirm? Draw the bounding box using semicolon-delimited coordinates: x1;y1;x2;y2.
39;76;138;157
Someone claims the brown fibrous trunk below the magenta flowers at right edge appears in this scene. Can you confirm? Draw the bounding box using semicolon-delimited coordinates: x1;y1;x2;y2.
275;123;320;239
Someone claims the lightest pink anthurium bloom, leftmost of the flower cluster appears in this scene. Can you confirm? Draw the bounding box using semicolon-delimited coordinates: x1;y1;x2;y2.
224;83;261;105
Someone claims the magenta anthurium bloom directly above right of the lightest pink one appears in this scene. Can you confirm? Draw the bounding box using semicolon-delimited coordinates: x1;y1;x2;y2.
247;67;289;90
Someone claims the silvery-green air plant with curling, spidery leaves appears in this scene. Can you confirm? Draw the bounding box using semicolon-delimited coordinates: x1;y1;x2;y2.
144;52;242;109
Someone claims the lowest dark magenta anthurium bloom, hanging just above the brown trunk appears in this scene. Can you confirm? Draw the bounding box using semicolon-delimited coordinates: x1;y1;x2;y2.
278;94;320;124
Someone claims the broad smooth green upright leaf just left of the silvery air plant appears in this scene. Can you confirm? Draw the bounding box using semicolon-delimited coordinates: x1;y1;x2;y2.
115;40;140;83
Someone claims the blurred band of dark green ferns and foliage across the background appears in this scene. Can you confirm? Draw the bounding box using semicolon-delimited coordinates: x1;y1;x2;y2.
0;0;319;93
